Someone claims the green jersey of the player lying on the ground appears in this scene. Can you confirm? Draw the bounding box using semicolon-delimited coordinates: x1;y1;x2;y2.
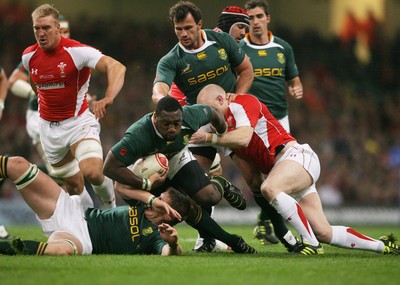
85;205;167;254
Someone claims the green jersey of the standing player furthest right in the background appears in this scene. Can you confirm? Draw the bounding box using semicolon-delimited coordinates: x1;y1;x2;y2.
239;33;299;120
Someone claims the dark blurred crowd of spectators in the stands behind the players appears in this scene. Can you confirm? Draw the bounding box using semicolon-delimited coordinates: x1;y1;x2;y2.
0;3;400;206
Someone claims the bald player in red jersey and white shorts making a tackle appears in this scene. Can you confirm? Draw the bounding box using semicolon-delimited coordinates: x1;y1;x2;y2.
190;84;400;255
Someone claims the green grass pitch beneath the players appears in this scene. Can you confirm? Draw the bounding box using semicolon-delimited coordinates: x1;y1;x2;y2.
0;224;400;285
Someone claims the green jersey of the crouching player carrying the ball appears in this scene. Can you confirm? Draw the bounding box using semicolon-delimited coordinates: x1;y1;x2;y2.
111;104;211;165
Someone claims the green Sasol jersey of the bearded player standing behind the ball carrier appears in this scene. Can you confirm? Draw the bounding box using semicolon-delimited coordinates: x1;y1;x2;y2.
154;29;245;105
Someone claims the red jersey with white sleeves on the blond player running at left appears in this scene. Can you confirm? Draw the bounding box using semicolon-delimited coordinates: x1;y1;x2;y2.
22;37;103;121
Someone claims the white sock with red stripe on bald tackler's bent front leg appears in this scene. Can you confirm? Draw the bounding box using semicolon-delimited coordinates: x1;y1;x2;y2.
271;192;319;246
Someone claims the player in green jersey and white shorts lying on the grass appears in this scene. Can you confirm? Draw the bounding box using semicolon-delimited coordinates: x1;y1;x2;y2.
0;156;191;255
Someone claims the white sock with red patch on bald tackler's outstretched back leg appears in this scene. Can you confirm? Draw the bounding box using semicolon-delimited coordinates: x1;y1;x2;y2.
330;226;385;253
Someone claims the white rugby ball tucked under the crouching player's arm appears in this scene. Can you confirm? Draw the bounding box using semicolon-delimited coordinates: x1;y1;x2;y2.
128;153;168;178
